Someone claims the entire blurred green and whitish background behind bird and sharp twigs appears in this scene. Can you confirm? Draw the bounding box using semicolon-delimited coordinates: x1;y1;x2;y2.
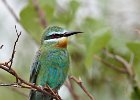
0;0;140;100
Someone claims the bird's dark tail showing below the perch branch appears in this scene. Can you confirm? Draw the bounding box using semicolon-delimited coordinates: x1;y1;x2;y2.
29;90;53;100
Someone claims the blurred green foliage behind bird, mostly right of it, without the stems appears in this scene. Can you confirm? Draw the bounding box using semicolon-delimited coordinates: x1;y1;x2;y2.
0;0;140;100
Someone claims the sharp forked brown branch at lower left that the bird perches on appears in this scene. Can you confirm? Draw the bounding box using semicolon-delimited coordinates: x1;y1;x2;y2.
0;26;61;100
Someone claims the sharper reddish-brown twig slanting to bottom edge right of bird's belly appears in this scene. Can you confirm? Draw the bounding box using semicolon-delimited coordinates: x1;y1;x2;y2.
69;76;95;100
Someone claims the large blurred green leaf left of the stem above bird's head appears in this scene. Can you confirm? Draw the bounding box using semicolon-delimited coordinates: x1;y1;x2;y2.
20;4;43;43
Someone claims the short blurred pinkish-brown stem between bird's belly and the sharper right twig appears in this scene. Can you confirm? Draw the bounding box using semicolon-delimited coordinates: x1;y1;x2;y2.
65;78;80;100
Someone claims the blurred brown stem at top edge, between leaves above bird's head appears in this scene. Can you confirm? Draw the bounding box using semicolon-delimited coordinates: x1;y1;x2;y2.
32;0;47;28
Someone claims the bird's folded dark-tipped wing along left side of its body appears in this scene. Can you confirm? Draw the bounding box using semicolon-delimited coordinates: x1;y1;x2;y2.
30;51;41;83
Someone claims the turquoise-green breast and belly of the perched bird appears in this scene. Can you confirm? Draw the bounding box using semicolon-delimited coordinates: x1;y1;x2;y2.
38;49;69;89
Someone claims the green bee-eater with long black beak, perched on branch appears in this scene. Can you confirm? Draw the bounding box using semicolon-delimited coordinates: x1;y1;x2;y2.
29;26;82;100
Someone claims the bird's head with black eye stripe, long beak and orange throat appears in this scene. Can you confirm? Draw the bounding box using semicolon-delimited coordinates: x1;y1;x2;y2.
41;26;82;48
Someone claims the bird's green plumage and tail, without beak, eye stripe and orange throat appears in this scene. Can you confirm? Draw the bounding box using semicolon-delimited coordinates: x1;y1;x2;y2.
30;27;69;100
